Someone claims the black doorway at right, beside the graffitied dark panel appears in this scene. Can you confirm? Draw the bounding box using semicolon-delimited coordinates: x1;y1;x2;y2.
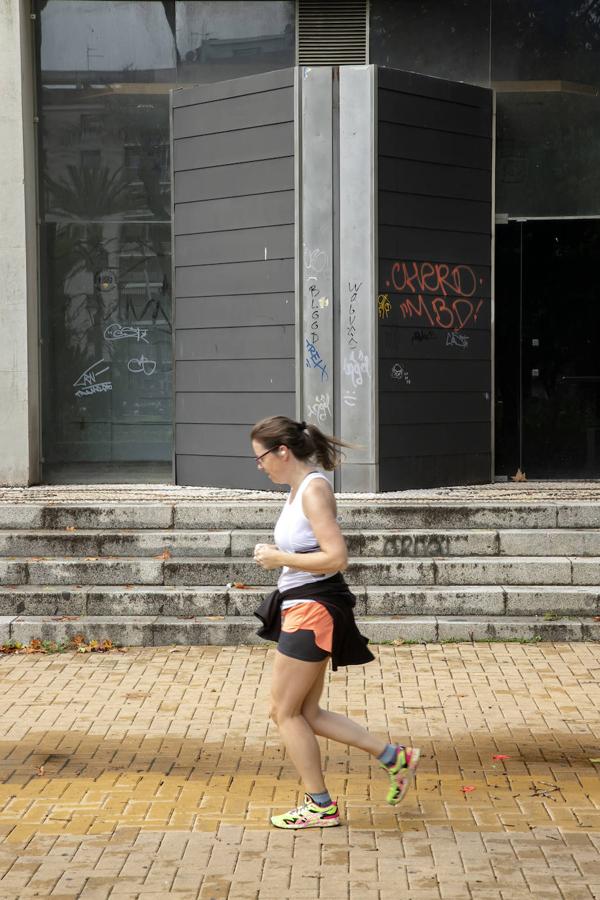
495;219;600;478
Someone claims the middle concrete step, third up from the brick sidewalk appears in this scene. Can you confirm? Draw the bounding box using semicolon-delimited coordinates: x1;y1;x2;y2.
0;556;600;587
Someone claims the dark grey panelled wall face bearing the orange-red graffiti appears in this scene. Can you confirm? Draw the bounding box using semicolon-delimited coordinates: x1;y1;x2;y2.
377;68;492;491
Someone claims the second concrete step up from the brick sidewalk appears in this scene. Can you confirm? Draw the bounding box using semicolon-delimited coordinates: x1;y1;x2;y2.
0;585;600;617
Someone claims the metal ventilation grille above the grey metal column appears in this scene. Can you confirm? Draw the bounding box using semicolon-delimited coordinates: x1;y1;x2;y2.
296;0;369;66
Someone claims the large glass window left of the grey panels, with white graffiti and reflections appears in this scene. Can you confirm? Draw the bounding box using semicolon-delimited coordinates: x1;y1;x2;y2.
37;0;294;481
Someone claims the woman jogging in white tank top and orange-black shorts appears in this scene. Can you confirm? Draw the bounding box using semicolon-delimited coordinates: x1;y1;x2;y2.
251;416;419;828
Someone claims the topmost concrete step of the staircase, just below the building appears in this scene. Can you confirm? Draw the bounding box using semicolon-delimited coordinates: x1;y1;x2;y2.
0;495;600;530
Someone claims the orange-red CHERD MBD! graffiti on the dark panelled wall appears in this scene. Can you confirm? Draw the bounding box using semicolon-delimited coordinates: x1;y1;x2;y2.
386;261;484;331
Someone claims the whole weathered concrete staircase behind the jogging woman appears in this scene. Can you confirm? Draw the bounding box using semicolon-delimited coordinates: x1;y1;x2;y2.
0;486;600;646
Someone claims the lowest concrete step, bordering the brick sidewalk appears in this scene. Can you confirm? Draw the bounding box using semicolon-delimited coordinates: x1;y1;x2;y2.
0;616;600;646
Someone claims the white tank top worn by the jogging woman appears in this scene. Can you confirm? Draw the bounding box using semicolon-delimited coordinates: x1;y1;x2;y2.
274;472;329;609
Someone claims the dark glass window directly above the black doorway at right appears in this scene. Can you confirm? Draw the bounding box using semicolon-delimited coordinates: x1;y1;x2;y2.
492;0;600;218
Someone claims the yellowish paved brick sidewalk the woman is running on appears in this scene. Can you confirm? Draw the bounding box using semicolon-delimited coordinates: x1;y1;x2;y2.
0;644;600;900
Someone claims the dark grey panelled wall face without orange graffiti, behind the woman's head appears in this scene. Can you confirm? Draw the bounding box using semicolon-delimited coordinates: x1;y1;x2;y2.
172;69;295;489
